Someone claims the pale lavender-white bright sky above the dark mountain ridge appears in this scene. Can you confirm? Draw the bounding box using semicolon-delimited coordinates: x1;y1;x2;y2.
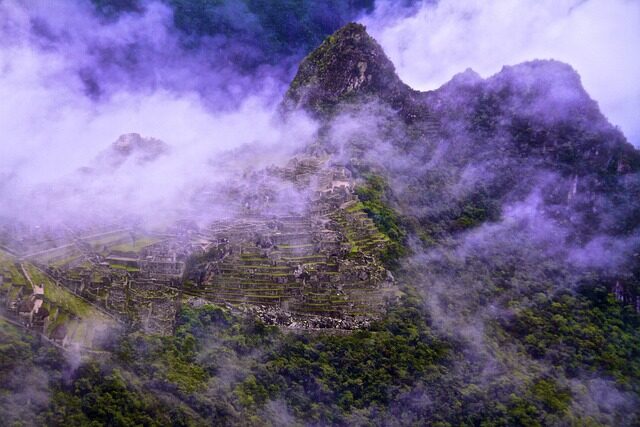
363;0;640;147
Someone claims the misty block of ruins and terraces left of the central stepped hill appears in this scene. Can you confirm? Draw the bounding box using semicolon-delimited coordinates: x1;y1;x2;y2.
47;236;188;334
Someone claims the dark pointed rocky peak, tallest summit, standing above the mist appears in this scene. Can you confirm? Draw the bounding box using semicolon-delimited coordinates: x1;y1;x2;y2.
285;23;410;114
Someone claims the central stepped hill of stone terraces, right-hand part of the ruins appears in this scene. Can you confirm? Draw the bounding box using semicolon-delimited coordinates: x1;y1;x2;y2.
184;158;392;327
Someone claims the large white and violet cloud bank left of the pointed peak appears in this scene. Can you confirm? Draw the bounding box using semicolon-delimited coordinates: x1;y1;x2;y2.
0;1;315;227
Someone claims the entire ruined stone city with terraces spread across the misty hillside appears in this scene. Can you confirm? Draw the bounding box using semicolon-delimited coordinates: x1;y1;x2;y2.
0;149;393;334
